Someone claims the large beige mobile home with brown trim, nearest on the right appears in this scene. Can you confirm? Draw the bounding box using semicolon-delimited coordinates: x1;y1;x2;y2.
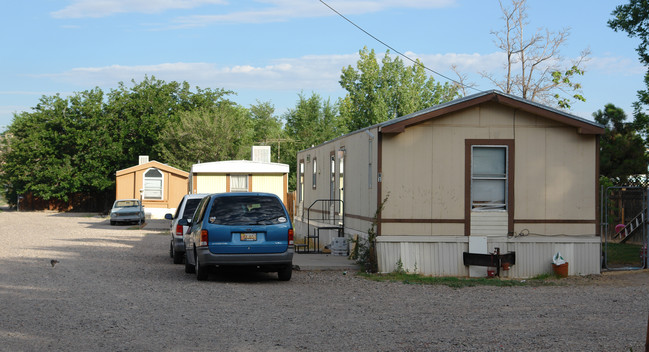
295;91;604;278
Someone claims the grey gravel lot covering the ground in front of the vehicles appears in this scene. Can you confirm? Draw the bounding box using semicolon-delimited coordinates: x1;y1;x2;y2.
0;211;649;351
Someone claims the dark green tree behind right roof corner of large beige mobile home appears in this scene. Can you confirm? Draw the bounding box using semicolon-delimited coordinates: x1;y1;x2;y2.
593;104;649;179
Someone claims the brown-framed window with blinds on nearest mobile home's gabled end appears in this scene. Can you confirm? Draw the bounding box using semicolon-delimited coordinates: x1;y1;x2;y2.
471;146;508;210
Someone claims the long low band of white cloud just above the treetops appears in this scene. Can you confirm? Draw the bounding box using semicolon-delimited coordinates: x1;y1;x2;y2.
34;53;502;92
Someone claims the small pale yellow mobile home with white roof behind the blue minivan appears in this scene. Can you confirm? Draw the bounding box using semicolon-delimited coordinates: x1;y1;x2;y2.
189;160;289;204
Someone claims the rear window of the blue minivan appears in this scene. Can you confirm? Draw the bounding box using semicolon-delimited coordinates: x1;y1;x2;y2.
209;196;287;225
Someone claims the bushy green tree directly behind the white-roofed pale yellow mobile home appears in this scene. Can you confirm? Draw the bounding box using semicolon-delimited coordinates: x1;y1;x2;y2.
160;104;254;170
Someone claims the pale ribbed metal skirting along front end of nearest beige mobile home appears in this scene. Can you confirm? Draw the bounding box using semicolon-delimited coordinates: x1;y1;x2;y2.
377;236;601;278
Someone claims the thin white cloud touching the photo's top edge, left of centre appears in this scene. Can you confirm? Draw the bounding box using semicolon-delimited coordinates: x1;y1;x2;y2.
51;0;226;18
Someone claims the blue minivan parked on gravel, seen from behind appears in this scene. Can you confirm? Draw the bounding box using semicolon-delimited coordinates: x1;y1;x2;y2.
180;192;294;281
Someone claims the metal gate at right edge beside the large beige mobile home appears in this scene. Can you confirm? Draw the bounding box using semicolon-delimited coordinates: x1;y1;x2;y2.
601;186;649;270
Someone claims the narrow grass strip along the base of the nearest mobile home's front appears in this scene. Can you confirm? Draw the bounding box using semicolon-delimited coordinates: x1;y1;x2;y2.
359;272;557;288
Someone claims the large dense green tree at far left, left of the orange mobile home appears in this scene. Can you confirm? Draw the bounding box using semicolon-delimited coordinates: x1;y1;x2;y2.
0;88;120;205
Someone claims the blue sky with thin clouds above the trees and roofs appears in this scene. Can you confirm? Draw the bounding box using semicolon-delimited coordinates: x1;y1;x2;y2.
0;0;645;129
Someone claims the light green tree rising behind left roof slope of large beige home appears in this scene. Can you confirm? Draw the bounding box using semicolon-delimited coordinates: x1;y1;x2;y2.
340;47;458;131
